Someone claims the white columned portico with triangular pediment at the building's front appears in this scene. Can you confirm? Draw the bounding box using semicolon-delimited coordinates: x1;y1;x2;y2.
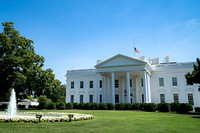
95;55;151;104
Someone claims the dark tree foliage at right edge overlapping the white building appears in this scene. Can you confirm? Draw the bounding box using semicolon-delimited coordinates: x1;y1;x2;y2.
185;58;200;85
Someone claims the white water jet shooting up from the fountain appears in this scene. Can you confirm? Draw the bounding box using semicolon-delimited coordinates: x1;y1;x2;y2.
7;89;17;117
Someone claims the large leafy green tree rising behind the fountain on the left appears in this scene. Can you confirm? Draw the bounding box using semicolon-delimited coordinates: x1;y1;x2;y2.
0;22;61;101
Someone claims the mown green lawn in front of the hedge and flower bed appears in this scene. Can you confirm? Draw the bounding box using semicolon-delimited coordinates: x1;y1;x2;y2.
0;110;200;133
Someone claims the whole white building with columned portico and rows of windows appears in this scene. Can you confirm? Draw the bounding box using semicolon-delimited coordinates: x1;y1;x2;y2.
66;54;200;107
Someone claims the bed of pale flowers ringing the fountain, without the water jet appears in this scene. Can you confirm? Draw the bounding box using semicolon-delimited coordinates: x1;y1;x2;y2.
0;112;93;123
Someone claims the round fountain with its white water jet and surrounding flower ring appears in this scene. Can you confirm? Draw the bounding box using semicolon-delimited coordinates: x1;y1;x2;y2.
0;89;93;123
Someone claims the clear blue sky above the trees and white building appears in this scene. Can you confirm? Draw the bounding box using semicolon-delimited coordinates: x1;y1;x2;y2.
0;0;200;84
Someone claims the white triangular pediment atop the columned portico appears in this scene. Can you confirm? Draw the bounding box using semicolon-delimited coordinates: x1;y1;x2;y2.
95;54;146;68
